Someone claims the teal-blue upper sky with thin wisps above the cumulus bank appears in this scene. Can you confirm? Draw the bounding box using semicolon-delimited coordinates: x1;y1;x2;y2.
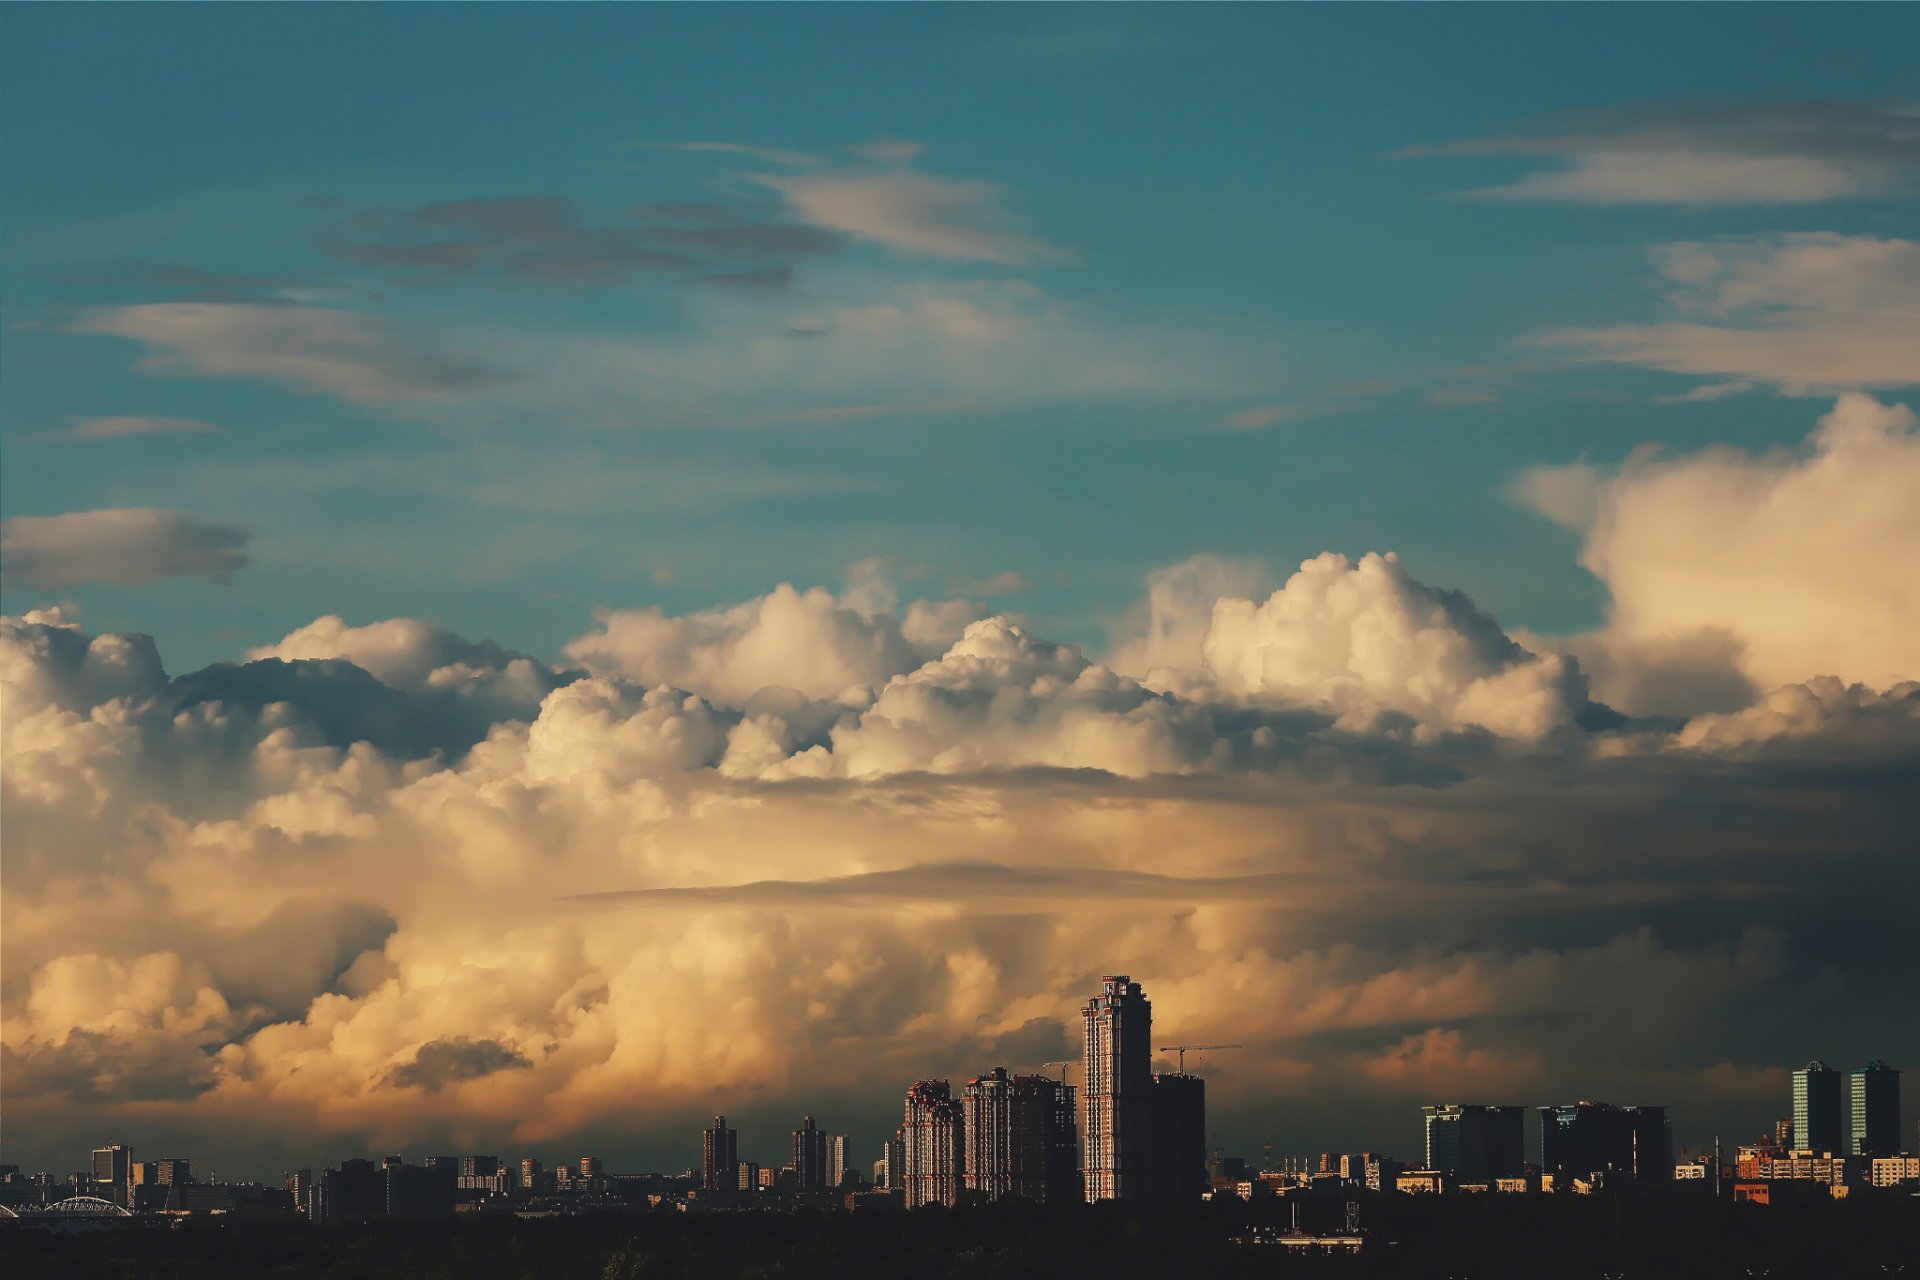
0;6;1920;666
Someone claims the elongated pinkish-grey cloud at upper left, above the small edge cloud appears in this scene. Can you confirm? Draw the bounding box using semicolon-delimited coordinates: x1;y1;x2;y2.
69;303;507;405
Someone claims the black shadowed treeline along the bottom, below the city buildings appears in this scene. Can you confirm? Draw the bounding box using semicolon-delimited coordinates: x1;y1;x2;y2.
0;1194;1920;1280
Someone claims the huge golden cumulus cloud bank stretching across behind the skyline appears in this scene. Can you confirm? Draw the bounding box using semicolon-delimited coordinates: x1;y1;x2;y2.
0;557;1920;1169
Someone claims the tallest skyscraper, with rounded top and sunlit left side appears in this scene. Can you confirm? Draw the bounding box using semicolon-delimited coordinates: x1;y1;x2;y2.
1081;973;1158;1201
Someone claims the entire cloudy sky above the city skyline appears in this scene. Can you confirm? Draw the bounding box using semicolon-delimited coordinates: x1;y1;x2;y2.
0;4;1920;1174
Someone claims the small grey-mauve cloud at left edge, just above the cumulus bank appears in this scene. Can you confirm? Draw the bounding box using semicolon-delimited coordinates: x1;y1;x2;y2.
0;507;248;589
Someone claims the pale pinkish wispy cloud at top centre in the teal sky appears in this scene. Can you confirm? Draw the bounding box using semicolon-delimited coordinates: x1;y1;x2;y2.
760;169;1054;263
